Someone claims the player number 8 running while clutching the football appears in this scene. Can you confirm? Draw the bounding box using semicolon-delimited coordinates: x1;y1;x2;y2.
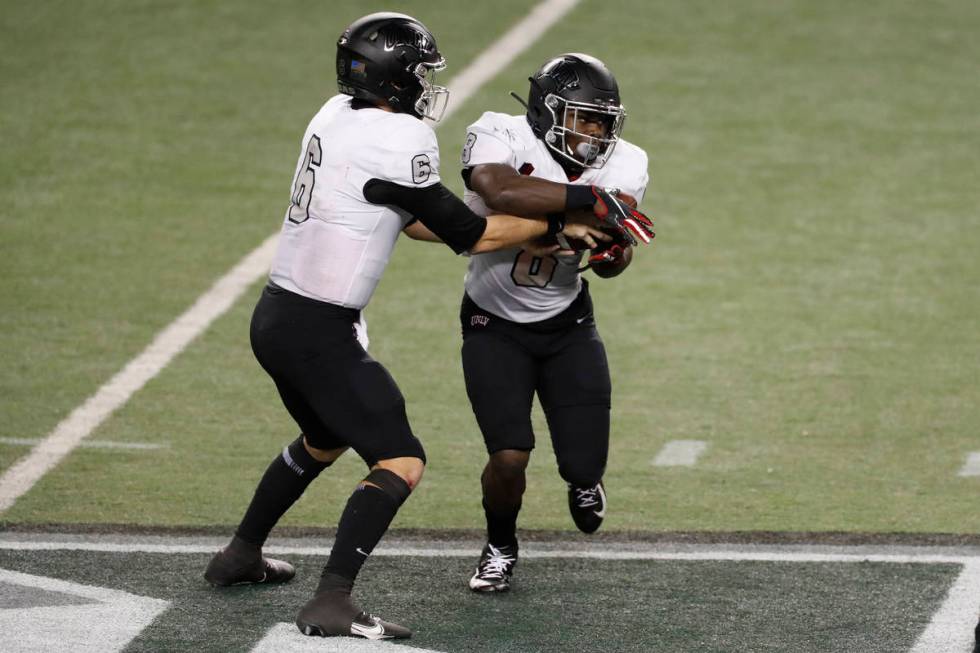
460;54;654;592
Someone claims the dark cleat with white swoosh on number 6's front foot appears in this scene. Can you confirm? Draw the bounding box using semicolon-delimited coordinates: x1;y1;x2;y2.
296;591;412;639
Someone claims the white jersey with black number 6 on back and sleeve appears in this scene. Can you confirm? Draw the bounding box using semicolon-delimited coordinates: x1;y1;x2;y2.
269;95;439;309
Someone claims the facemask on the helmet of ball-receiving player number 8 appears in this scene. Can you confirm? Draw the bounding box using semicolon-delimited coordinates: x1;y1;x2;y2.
544;93;626;169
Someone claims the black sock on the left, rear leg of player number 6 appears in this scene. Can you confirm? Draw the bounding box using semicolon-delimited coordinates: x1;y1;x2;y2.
235;435;330;546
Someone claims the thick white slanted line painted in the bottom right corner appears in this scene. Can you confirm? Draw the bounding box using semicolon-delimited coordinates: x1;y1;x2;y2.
911;560;980;653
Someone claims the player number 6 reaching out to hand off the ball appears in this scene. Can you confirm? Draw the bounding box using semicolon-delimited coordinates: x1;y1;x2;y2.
204;13;606;639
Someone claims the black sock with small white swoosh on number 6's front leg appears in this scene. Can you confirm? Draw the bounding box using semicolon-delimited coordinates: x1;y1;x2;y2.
317;469;411;593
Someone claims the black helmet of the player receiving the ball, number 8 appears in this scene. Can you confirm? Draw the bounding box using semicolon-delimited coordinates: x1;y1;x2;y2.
527;53;626;168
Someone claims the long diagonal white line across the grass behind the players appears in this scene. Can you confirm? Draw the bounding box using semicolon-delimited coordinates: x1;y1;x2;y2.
0;0;579;513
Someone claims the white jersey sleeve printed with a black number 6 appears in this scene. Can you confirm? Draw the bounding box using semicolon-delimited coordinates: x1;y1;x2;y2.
365;116;440;188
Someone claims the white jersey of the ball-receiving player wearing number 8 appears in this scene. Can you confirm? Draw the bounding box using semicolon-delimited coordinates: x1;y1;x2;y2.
462;111;649;322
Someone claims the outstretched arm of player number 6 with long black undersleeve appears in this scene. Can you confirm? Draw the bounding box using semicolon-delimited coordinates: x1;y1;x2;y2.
363;179;607;254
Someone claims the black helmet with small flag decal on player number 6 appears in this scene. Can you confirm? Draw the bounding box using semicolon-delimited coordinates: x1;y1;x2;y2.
337;12;449;120
